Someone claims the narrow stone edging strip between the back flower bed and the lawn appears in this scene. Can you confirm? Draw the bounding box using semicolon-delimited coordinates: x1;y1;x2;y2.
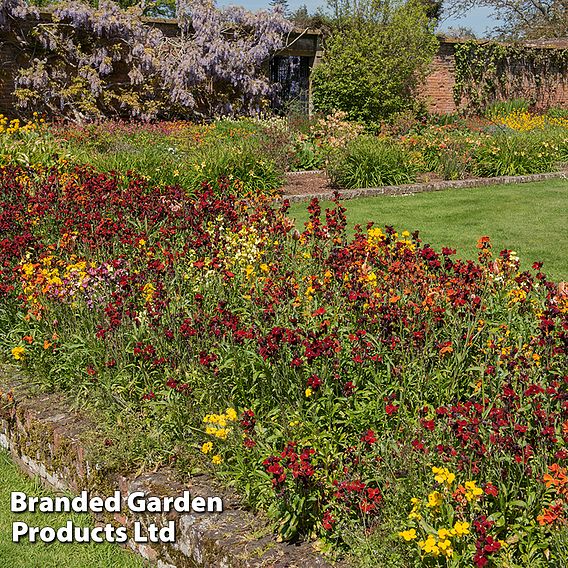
281;171;568;203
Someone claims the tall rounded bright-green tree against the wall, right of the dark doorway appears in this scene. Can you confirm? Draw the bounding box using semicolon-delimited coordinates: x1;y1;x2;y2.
312;0;438;126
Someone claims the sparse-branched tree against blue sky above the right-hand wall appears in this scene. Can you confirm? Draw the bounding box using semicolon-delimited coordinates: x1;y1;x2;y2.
447;0;568;39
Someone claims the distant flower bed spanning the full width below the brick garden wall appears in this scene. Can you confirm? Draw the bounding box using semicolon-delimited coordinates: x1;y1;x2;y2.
0;111;568;195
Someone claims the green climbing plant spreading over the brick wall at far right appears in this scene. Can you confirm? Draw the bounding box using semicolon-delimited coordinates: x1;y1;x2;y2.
454;41;568;112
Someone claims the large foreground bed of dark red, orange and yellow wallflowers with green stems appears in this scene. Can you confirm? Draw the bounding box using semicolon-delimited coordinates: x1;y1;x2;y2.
0;162;568;566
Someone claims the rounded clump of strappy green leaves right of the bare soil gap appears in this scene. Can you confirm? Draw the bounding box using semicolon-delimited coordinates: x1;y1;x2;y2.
327;136;416;188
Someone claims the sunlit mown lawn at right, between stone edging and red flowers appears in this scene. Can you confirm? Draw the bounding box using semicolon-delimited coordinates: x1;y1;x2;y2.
290;180;568;281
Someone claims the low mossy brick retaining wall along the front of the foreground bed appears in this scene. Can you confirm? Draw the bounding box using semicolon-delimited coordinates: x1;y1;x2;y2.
0;365;337;568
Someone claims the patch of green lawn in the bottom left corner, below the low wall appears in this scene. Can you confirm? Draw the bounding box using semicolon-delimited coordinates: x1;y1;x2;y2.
0;451;144;568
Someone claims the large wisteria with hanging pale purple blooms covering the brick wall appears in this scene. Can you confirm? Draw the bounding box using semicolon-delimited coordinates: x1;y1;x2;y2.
0;0;292;120
